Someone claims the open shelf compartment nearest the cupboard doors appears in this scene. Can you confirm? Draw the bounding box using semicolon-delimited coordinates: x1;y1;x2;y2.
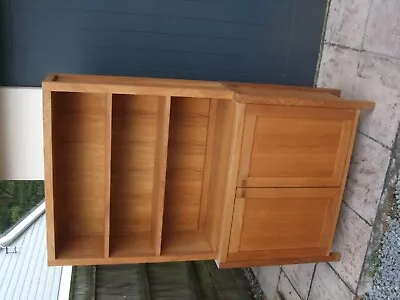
161;97;214;258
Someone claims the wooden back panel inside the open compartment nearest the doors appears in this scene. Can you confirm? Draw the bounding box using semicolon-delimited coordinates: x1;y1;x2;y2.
164;97;210;231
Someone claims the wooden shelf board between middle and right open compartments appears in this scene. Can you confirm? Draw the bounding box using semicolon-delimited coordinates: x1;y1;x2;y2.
151;96;171;256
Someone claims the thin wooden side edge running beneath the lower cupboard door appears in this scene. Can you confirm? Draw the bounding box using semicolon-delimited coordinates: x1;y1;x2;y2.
215;252;341;269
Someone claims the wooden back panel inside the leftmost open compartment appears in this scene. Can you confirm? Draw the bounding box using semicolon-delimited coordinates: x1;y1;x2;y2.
52;92;106;238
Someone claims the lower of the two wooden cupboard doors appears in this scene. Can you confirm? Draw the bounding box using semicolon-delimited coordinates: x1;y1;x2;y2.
227;188;341;262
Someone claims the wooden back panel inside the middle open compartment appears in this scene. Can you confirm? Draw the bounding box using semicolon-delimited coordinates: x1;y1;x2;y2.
110;95;162;235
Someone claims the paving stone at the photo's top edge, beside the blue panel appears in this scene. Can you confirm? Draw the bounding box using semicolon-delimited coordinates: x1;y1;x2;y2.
325;0;371;49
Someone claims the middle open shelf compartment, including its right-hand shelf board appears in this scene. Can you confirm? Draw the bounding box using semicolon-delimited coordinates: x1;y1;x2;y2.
109;94;170;257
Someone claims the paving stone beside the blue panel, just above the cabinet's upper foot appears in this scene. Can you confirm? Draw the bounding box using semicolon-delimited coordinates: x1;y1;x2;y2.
317;44;361;98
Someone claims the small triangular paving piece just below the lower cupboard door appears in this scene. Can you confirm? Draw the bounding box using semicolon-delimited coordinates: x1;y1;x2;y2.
283;264;315;299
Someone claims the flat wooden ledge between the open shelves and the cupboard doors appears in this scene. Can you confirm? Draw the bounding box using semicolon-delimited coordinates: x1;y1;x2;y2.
206;99;245;259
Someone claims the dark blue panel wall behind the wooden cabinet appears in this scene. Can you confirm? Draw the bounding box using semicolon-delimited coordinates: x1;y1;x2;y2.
0;0;326;86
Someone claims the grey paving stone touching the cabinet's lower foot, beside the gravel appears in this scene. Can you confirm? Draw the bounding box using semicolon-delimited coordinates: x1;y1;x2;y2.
330;204;372;291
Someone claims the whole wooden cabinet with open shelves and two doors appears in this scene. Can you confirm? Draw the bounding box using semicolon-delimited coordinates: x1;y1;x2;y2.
43;75;374;267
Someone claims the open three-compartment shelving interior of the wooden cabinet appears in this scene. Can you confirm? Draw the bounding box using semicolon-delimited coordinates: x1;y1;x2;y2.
49;84;216;260
